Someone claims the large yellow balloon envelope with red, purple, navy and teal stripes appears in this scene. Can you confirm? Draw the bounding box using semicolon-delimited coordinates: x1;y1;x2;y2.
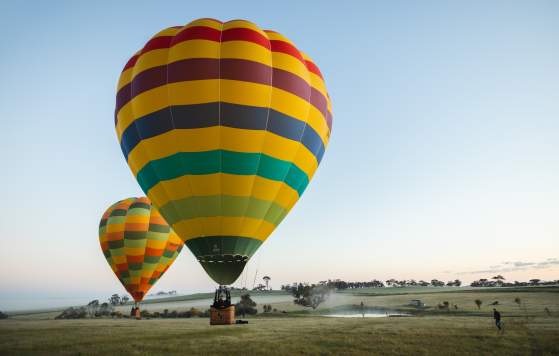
115;19;332;285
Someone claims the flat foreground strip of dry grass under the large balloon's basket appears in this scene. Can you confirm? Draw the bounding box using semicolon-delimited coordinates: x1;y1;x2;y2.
0;317;559;355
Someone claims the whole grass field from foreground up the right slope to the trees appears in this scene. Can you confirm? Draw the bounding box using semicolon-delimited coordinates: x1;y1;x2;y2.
0;288;559;355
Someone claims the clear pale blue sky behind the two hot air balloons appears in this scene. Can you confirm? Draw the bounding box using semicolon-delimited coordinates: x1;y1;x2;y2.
0;0;559;309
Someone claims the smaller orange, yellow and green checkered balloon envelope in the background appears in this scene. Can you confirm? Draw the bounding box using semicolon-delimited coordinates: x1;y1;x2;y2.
99;198;184;302
